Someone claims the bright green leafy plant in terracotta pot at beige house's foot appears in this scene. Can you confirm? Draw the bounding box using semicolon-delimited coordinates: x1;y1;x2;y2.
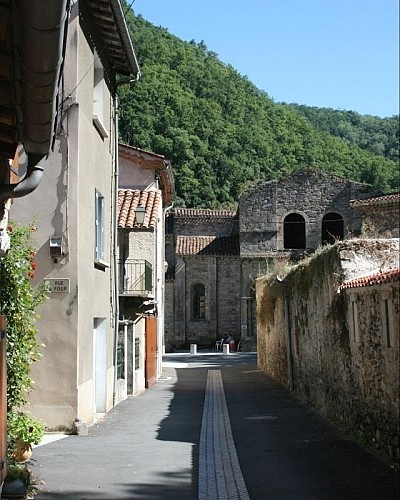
7;411;45;463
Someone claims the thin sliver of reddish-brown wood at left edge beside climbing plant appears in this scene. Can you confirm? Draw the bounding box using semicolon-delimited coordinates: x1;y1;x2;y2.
0;316;7;485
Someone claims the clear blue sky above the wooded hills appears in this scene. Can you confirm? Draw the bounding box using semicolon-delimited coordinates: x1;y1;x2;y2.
128;0;399;117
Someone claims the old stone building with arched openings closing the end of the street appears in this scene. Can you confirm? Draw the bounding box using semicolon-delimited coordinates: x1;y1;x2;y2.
165;168;377;351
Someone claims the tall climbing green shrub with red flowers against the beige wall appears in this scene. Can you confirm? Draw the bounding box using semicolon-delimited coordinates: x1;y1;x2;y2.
0;223;47;460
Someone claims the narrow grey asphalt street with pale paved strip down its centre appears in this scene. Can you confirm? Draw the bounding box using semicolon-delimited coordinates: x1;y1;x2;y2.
32;352;399;500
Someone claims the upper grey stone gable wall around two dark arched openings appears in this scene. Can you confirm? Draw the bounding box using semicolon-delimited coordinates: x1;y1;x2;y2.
239;169;376;256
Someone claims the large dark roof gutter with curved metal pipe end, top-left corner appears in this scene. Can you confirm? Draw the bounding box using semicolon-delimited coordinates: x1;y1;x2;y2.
0;0;70;203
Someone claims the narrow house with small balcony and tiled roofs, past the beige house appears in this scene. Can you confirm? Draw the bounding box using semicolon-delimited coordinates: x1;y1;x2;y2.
118;144;173;395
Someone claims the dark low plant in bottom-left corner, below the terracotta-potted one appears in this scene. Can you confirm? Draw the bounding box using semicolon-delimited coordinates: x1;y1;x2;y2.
1;465;39;499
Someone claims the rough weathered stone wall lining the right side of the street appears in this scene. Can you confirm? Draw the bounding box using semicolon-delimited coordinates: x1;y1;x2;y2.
256;240;399;460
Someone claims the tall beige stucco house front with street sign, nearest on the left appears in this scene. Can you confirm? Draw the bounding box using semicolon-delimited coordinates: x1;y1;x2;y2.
11;2;139;428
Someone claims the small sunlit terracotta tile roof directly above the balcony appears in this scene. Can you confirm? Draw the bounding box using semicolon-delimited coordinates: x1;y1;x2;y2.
118;189;161;229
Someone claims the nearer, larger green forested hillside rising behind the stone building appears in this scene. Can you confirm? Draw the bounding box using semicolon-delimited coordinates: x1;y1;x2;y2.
119;11;399;208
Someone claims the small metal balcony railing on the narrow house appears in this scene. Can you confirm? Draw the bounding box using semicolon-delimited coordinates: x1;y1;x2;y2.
118;259;153;295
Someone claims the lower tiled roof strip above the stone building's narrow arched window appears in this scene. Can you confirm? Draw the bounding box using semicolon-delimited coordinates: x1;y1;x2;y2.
176;236;240;256
